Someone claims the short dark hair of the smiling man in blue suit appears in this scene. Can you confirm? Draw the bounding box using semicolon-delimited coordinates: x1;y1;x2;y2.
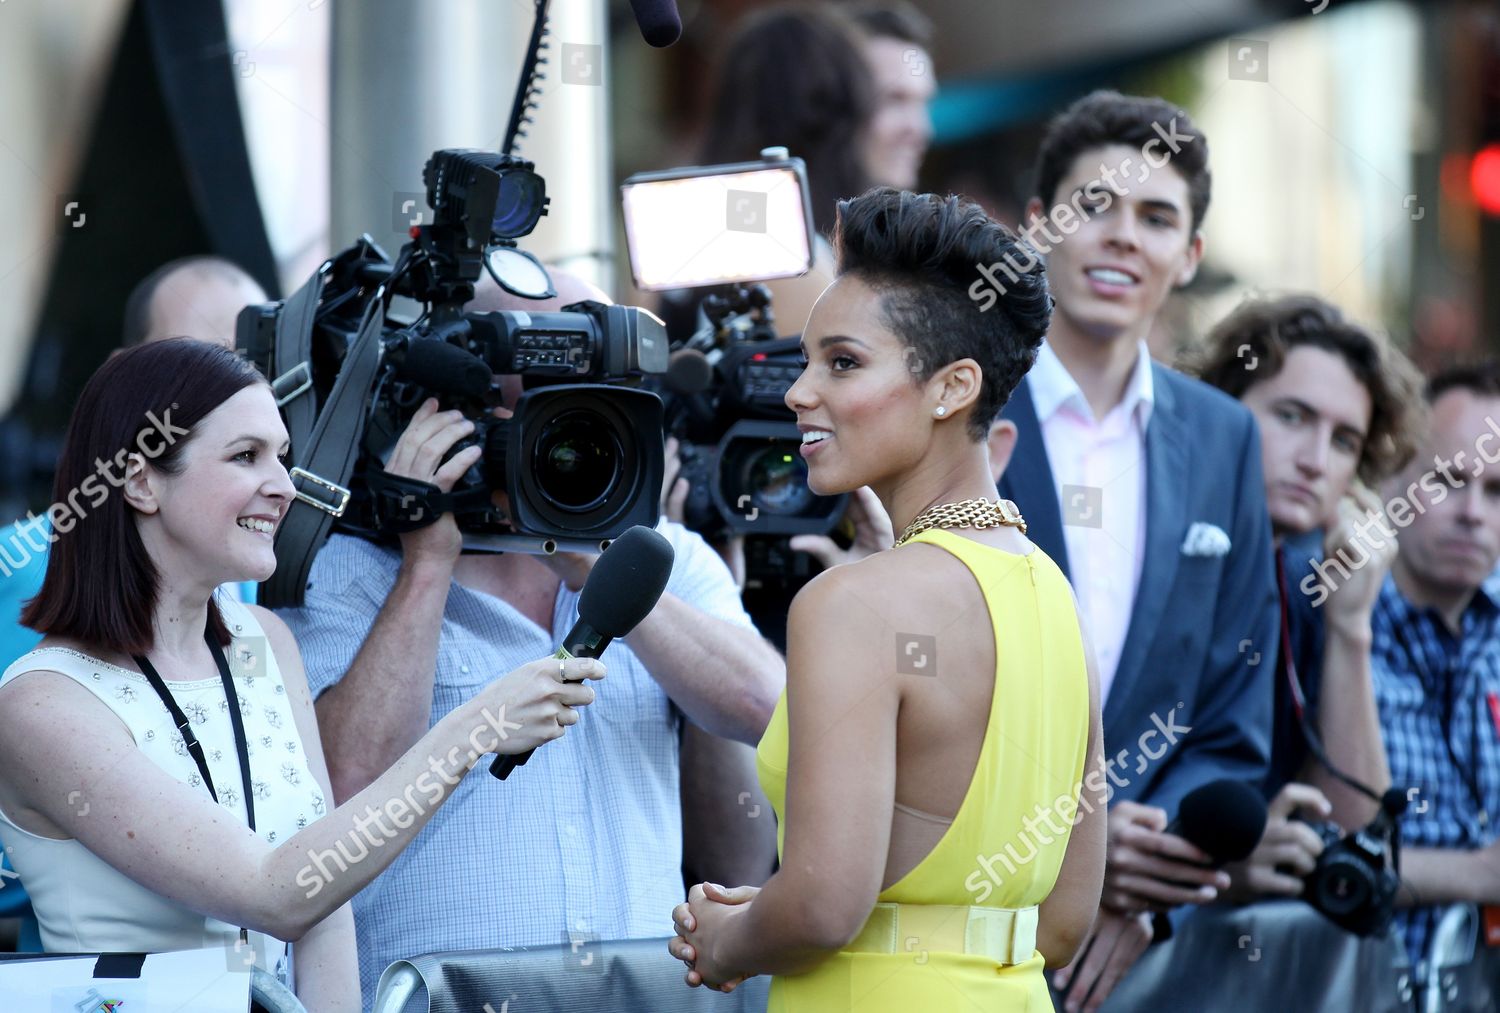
1037;90;1214;236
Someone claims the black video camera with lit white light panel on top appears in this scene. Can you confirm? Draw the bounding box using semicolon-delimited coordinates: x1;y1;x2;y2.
623;149;848;552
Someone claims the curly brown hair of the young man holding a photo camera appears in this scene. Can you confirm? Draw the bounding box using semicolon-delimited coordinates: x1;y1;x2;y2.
1196;296;1424;485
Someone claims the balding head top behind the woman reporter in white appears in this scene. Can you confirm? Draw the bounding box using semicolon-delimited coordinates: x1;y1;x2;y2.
125;257;267;348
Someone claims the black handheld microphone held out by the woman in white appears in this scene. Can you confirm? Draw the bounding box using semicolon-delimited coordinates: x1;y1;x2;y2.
489;524;674;780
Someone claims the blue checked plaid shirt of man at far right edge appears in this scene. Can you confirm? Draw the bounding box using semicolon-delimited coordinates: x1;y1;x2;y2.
1370;572;1500;966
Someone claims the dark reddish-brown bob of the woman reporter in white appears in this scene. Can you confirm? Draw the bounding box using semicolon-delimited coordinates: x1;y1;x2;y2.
21;338;266;654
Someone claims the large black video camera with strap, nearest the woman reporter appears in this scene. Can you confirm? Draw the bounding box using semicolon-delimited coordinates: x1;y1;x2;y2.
236;0;668;605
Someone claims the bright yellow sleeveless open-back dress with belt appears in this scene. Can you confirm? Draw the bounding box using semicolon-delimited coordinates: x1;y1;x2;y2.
756;528;1089;1013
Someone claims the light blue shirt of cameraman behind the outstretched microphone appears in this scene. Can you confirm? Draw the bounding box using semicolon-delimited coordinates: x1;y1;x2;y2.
278;521;755;1010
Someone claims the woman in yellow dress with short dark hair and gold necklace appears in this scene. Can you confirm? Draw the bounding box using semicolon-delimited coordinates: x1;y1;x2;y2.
669;189;1106;1013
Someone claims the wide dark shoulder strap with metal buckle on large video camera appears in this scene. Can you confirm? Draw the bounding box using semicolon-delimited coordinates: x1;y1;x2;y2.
261;293;386;608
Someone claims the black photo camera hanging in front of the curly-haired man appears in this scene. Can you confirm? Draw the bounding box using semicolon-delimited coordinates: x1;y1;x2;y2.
1302;788;1407;935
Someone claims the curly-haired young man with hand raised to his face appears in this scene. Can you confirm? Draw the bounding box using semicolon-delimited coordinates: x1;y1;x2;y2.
1200;296;1422;900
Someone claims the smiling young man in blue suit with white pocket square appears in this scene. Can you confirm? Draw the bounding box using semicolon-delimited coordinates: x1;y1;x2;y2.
971;92;1278;1008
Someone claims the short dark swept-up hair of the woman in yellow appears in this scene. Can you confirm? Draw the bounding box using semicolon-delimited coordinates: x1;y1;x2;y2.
834;186;1052;441
